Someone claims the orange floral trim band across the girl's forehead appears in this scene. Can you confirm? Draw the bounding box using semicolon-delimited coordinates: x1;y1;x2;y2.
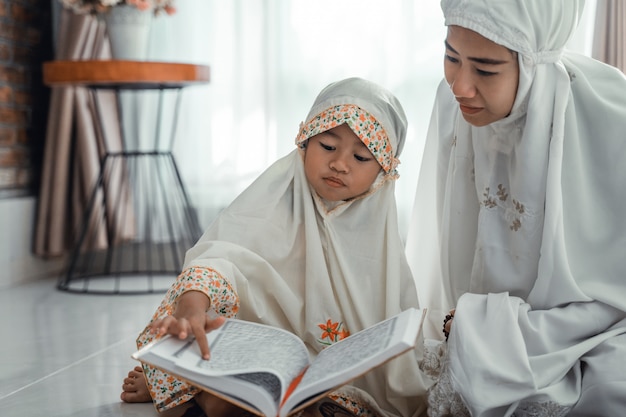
296;104;399;176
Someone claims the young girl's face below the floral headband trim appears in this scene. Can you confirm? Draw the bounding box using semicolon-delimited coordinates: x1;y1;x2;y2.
304;124;382;201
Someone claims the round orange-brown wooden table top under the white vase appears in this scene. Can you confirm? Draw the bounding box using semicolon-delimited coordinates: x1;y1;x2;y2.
43;60;210;89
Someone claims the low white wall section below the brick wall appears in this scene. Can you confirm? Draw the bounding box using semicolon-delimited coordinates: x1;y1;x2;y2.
0;197;65;290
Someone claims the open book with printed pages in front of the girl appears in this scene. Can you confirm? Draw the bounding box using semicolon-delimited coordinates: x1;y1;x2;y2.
132;308;425;417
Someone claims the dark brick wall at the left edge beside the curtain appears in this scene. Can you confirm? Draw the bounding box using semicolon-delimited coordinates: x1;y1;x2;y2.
0;0;53;199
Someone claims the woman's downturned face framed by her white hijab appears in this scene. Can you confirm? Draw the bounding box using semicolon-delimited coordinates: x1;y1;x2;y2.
444;26;519;126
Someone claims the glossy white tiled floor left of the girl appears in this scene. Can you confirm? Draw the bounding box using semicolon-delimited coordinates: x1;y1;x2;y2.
0;277;185;417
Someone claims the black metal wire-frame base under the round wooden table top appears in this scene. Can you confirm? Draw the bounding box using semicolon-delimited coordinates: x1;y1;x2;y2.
44;61;208;294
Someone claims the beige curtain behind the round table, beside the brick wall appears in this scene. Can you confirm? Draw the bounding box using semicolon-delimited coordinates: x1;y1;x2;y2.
34;9;129;257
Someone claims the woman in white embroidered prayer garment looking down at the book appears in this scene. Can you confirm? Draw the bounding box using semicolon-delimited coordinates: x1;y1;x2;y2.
407;0;626;416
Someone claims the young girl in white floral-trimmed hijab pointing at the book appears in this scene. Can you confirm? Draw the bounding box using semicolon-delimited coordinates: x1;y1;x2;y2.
122;78;425;417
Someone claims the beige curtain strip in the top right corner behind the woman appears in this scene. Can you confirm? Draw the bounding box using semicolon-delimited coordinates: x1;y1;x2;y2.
592;0;626;72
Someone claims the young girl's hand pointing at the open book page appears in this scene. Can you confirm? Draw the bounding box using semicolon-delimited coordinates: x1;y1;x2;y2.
150;291;224;360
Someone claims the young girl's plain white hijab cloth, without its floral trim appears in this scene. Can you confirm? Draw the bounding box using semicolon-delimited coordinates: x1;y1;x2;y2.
185;78;425;417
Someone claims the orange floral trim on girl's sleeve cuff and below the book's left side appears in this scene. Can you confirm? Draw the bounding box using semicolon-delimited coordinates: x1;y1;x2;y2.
137;268;239;411
